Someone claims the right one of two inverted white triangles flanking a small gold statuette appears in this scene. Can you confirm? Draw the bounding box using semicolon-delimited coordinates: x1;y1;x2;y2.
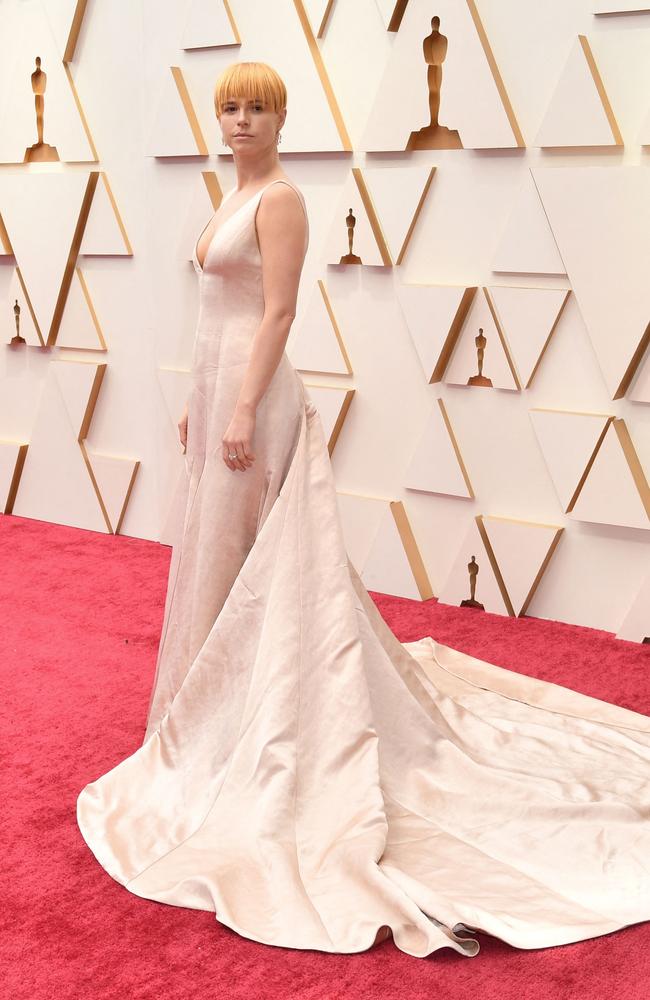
488;285;570;388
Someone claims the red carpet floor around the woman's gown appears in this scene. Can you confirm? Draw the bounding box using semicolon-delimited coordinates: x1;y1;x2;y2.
0;516;650;1000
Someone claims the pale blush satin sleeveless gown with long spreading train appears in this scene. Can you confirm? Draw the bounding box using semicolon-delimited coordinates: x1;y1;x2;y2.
77;180;650;957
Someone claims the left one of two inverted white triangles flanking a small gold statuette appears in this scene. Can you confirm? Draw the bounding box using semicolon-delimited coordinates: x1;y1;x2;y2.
395;282;467;382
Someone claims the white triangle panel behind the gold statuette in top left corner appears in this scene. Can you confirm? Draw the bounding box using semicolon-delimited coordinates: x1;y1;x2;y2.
0;2;97;162
